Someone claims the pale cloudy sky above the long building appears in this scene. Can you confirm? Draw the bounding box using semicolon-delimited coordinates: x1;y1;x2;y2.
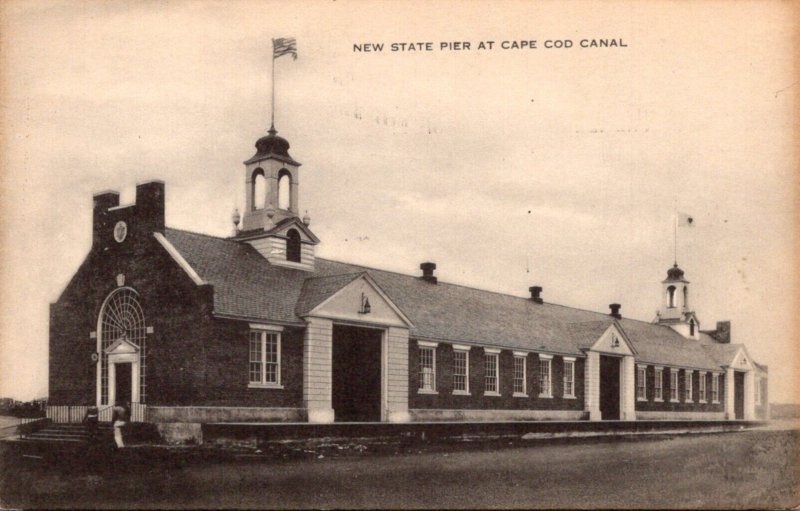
0;0;800;402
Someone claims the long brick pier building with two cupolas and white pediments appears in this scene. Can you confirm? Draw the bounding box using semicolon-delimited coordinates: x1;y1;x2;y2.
48;129;768;423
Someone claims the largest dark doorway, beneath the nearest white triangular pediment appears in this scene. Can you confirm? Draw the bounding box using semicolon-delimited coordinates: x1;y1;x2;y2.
332;325;382;422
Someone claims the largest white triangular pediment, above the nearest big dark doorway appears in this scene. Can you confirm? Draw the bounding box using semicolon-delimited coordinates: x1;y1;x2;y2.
301;272;412;328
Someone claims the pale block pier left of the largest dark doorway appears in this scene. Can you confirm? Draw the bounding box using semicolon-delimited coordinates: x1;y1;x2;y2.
303;318;334;423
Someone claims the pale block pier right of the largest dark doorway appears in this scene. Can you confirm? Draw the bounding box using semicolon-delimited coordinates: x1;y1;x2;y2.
383;327;411;422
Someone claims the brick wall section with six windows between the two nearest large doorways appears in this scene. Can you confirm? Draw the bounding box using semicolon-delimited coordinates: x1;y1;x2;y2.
408;340;584;411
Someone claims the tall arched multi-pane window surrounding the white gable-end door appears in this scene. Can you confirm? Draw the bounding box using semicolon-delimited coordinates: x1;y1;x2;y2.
98;287;147;404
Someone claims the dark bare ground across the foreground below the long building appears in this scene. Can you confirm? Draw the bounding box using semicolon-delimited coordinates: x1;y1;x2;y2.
0;430;800;509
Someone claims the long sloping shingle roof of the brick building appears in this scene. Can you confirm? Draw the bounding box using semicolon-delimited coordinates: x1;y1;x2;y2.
165;228;744;369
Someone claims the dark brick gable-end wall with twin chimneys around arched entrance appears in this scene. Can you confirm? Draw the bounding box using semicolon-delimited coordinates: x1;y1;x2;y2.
49;183;214;405
